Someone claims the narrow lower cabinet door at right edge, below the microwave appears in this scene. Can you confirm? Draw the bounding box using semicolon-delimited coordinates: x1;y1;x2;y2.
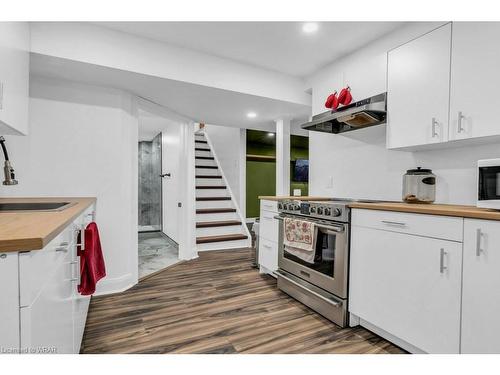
461;219;500;353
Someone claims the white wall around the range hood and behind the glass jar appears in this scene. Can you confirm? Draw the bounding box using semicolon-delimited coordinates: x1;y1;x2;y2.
309;24;500;204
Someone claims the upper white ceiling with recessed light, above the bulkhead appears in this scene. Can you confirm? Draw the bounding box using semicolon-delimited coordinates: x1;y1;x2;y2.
97;21;404;77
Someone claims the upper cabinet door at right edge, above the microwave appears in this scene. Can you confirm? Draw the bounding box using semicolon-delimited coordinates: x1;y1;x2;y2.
450;22;500;139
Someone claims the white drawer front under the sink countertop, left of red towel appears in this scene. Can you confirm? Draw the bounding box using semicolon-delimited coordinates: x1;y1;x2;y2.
19;225;76;307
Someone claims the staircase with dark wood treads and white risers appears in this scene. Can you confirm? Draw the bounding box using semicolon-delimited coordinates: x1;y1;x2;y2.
195;131;251;251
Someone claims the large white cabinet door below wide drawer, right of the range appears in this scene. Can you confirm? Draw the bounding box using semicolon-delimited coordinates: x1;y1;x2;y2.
349;227;462;353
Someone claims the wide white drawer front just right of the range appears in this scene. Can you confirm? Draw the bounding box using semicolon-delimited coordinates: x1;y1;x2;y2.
351;209;464;242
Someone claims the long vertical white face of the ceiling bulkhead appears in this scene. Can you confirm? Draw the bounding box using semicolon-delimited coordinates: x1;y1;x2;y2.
31;22;311;105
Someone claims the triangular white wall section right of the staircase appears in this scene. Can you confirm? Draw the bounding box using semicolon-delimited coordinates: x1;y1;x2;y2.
201;124;246;209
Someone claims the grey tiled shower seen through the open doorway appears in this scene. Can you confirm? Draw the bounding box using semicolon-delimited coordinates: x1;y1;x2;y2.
139;133;162;232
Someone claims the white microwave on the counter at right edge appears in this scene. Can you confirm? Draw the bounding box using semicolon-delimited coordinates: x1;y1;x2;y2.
477;159;500;210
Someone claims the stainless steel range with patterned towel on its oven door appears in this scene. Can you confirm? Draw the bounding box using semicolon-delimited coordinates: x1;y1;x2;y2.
276;199;351;327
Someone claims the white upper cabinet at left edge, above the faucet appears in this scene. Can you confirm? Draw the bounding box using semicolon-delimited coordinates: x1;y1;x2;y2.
0;22;30;135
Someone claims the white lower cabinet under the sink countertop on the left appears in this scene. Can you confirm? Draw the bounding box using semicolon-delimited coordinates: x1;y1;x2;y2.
0;207;94;354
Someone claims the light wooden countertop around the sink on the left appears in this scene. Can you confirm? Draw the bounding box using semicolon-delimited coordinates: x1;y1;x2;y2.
0;197;96;252
